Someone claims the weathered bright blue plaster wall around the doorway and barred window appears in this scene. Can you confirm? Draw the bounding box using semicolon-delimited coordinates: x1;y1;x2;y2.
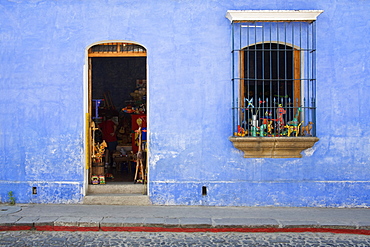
0;0;370;207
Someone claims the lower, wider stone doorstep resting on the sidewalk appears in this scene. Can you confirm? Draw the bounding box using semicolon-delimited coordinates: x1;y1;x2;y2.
83;194;152;206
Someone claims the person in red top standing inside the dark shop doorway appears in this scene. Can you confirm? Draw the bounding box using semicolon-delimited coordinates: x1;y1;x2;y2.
99;113;118;166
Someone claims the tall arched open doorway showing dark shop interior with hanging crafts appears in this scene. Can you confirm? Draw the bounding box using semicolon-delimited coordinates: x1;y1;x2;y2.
87;42;147;184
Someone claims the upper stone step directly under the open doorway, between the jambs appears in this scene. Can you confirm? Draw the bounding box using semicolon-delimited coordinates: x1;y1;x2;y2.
87;183;146;194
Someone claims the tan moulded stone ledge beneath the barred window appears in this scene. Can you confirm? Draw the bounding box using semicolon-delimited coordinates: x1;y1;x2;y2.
229;137;319;158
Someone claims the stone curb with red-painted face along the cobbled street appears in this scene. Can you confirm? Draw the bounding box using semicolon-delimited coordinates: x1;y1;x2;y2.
0;215;370;235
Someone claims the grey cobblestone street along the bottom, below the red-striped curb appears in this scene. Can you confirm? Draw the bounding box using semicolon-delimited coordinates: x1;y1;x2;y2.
0;231;370;247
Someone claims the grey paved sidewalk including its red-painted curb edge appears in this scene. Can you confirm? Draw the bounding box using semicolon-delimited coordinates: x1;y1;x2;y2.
0;204;370;234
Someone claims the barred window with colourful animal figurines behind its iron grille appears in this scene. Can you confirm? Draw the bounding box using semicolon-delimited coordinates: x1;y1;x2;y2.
231;20;316;137
